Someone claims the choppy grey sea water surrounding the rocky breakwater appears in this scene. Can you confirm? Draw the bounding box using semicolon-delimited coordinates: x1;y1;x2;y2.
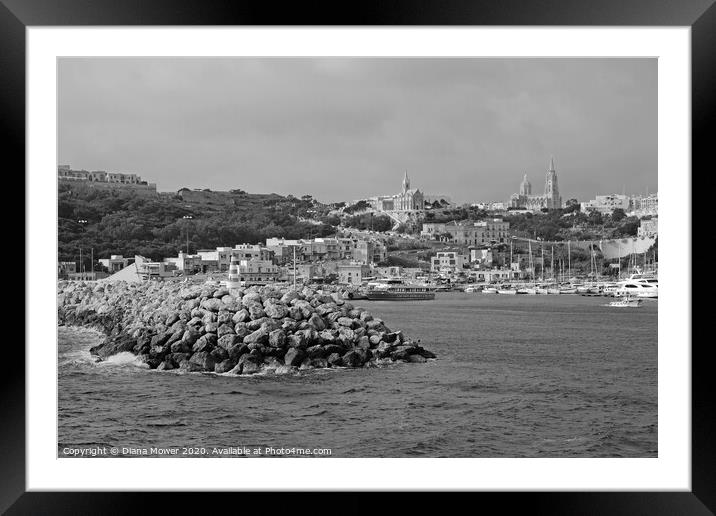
58;293;657;457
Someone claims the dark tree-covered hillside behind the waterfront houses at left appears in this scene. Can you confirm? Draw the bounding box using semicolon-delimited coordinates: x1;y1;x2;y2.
57;185;335;268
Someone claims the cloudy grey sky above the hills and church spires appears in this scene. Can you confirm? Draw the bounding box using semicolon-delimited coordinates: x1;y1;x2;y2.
58;58;657;202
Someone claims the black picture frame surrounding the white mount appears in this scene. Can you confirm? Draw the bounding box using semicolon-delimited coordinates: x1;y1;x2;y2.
5;0;704;514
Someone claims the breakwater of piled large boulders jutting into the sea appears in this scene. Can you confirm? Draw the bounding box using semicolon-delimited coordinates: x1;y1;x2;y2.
58;282;435;374
